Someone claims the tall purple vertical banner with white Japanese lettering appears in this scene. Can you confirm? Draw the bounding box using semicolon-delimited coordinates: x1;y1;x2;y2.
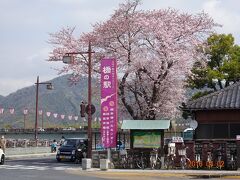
101;59;117;148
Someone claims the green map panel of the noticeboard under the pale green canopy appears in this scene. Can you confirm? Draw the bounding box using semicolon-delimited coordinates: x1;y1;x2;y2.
132;131;161;148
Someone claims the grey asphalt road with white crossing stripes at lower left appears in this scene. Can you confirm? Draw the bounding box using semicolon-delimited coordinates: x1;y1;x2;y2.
0;157;100;180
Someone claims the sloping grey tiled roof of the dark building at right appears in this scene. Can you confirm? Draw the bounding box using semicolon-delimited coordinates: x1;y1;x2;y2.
186;82;240;110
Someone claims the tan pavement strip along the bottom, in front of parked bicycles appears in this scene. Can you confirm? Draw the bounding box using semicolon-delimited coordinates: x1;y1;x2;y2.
68;168;240;180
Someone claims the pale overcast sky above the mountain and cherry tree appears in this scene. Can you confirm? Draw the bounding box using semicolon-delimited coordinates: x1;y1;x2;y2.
0;0;240;96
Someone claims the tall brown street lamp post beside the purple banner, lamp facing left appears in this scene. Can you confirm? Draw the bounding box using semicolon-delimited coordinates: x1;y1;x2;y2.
62;42;94;158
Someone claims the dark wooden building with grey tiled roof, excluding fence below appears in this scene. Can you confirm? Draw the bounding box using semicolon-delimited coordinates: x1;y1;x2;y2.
186;82;240;140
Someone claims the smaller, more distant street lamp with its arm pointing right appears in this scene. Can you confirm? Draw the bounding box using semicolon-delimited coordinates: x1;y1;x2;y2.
35;76;53;146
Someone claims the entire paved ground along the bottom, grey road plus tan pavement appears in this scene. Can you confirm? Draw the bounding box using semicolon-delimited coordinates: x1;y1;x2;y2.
0;156;240;180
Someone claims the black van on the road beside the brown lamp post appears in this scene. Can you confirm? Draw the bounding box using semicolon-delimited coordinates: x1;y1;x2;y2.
56;138;88;162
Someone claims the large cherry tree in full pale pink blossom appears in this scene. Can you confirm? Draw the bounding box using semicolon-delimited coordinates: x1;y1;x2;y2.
50;0;217;119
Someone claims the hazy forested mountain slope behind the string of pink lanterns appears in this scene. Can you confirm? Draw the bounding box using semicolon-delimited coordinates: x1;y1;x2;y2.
0;75;100;128
